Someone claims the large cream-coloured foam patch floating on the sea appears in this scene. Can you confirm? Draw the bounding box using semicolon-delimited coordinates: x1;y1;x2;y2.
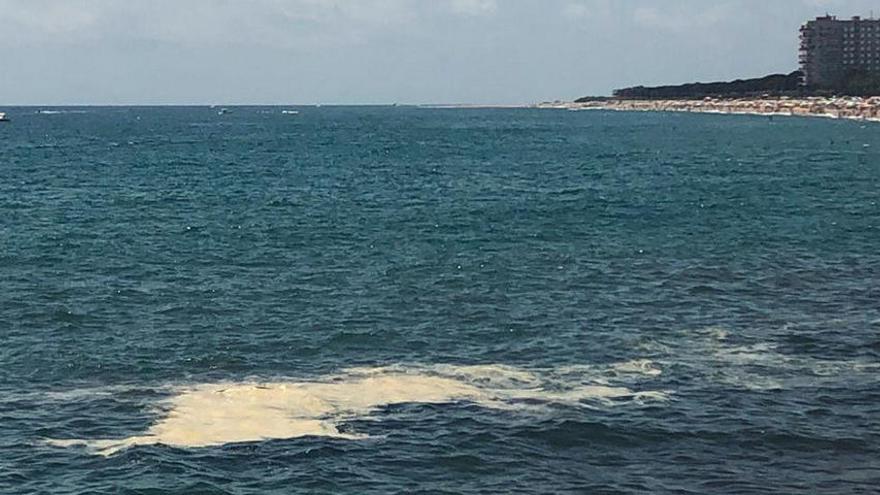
48;364;666;455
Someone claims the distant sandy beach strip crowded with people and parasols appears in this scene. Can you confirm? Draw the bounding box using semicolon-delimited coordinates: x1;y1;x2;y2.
535;96;880;122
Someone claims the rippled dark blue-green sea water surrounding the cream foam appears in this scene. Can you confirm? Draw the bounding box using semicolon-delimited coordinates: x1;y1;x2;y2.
0;107;880;494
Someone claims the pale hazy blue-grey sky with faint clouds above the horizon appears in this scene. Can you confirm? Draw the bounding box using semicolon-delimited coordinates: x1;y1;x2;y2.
0;0;880;105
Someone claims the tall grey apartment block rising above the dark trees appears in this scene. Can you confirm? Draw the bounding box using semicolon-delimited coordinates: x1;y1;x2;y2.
800;15;880;88
